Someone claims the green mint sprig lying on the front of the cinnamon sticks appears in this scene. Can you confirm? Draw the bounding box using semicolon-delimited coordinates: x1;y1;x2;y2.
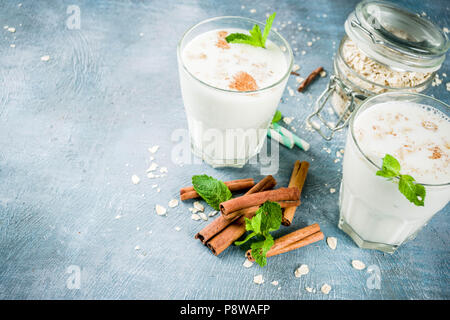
234;201;282;267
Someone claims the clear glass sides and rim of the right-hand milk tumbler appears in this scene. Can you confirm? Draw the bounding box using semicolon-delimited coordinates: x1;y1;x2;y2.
339;93;450;253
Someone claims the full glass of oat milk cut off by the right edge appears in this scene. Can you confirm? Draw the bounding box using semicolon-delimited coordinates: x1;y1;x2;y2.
339;93;450;253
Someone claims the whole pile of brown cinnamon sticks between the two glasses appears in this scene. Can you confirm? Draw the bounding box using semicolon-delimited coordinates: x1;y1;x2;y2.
180;161;323;260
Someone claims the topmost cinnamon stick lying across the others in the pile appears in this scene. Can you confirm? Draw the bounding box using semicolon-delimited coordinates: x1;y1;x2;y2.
220;187;300;219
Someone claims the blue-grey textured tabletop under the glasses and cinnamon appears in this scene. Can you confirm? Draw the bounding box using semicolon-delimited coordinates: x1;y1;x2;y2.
0;0;450;299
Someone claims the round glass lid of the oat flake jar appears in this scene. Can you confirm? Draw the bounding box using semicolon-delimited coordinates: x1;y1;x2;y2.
345;1;450;72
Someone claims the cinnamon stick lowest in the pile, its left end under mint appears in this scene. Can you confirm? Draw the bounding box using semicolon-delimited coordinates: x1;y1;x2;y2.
246;223;324;261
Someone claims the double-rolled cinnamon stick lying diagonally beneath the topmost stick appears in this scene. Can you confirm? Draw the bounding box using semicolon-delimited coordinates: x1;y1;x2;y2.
195;175;277;255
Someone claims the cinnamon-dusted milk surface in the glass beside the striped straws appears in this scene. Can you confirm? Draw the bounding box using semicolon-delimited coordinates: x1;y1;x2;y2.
182;29;287;91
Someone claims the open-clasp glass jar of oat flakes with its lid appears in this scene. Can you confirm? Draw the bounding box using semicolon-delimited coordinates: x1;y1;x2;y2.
307;1;450;140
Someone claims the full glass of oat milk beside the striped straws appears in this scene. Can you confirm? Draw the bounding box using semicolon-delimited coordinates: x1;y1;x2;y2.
177;17;293;167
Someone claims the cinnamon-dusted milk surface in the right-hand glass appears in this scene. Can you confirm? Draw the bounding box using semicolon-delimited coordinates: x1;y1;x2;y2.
354;101;450;184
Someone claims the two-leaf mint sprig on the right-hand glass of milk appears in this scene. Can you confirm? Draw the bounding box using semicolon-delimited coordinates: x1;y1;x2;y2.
377;154;426;207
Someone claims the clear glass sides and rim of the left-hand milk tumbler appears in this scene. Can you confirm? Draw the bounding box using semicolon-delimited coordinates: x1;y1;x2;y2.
177;17;293;167
